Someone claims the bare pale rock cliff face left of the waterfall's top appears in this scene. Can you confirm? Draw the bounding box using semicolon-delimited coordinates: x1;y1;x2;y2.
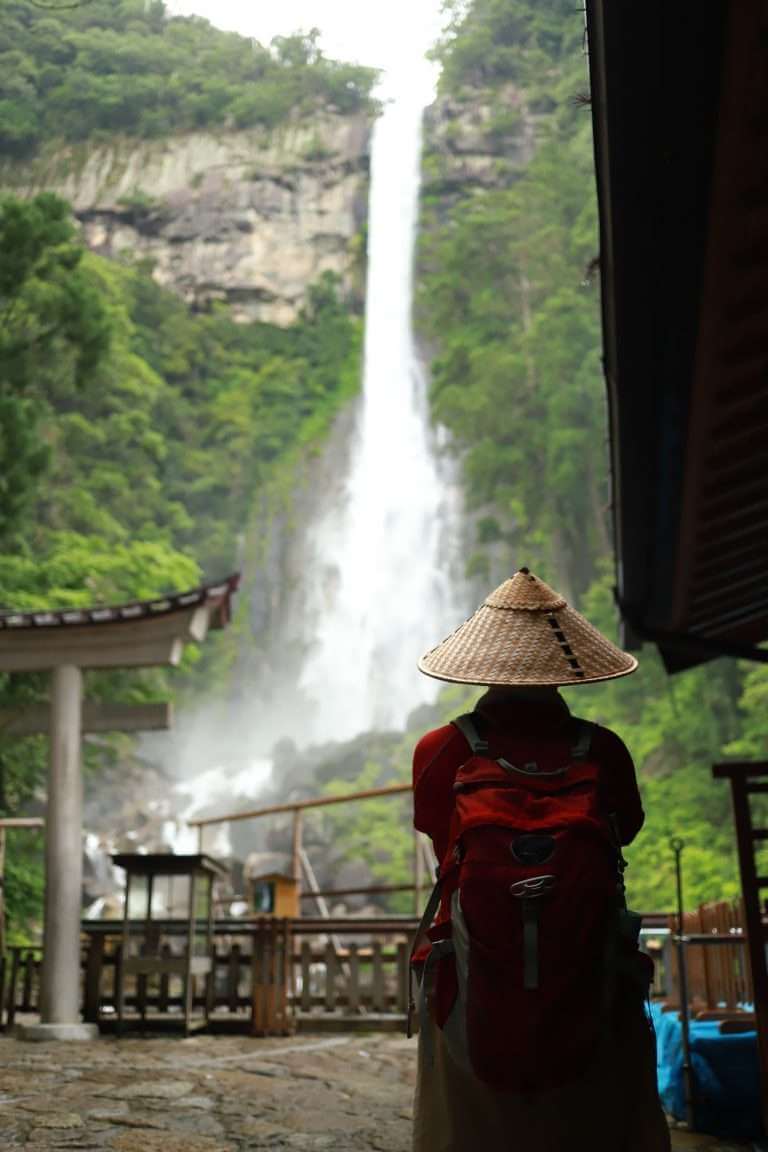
0;113;371;325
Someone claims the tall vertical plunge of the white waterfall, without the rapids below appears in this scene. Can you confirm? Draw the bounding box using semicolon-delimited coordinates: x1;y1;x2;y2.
301;90;461;741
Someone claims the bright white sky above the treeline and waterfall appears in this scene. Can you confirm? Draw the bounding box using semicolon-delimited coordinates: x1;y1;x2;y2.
168;0;442;98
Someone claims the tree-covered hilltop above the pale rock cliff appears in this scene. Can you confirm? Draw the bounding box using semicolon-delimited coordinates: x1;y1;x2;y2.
0;0;375;154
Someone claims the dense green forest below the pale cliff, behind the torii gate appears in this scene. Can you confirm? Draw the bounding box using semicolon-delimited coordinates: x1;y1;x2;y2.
0;195;360;944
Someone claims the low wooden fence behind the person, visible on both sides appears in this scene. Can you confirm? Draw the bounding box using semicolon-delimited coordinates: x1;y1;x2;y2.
0;902;752;1036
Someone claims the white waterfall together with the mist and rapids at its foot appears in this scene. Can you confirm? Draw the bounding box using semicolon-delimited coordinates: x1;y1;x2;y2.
138;42;467;855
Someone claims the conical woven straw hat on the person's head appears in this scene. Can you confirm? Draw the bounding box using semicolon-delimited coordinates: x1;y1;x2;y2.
419;568;638;685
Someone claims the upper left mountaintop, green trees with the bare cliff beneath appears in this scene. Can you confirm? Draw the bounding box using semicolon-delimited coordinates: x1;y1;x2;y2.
0;0;375;325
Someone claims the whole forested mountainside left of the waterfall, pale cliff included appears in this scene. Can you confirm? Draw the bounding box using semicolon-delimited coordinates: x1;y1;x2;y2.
0;0;374;939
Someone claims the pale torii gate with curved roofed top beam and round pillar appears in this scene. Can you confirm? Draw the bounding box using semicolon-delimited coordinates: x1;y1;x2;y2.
0;575;239;1039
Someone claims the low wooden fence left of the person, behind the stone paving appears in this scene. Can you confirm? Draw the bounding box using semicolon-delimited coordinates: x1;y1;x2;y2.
0;917;417;1036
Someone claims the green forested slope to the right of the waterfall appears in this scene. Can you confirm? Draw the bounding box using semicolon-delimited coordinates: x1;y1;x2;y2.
418;0;768;909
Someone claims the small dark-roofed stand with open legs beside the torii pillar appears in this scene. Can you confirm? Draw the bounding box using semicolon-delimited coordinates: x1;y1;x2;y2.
112;852;227;1034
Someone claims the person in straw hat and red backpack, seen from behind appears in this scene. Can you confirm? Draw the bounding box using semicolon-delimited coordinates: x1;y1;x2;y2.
411;568;670;1152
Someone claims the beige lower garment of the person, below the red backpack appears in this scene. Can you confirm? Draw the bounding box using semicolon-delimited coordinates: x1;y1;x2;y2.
413;1001;670;1152
